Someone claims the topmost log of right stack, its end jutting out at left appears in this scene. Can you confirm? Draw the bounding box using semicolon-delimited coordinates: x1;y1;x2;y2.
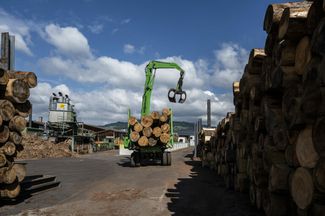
263;2;306;33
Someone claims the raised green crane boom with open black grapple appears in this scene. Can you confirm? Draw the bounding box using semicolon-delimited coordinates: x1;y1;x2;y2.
141;61;186;116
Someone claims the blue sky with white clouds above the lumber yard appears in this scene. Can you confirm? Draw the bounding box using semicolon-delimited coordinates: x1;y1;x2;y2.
0;0;284;124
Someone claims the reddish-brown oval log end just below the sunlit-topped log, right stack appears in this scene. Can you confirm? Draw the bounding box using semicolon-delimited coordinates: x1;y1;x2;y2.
295;36;311;75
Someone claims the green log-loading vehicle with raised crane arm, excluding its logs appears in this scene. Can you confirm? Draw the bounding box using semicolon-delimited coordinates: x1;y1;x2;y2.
124;61;187;166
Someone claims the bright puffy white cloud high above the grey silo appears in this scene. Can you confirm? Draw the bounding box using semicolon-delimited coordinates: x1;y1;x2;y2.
44;24;91;58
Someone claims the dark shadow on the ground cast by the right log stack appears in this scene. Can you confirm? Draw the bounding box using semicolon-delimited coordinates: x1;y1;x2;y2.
165;155;263;216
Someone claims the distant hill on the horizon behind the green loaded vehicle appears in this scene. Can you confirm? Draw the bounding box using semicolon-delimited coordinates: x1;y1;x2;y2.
102;121;194;135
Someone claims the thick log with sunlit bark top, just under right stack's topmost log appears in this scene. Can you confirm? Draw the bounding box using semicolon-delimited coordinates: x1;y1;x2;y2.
278;2;311;41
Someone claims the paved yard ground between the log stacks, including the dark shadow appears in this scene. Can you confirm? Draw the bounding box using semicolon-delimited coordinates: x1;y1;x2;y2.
0;149;261;216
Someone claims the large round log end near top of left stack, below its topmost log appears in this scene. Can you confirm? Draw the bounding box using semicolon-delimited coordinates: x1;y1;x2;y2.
5;79;30;103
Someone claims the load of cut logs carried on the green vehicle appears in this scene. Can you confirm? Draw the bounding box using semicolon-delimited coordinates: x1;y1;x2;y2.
129;108;172;147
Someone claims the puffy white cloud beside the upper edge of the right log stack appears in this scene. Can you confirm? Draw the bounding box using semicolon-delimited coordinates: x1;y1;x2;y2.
212;43;248;87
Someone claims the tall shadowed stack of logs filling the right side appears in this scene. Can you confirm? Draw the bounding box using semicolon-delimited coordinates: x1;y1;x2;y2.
211;0;325;216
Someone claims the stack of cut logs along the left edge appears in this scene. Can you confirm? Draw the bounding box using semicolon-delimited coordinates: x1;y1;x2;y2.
0;69;37;199
